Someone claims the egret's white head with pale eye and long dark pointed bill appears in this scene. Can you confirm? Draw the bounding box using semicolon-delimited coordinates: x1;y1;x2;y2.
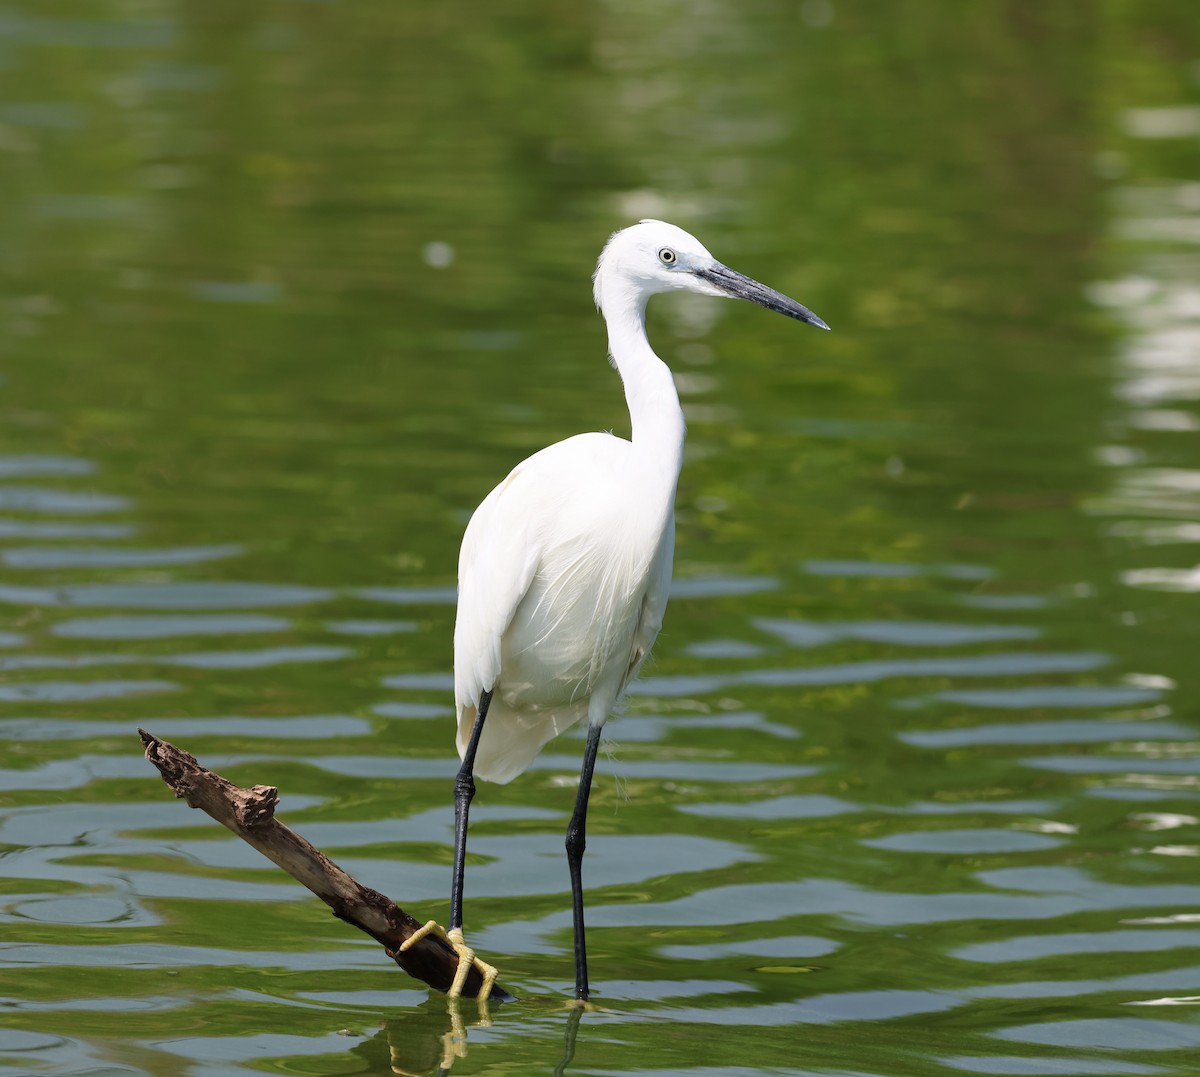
594;221;829;329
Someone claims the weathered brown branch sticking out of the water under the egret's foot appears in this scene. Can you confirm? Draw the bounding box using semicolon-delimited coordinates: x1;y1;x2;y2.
138;729;512;1001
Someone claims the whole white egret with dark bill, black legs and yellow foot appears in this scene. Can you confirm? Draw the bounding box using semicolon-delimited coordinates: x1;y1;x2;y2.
400;221;829;999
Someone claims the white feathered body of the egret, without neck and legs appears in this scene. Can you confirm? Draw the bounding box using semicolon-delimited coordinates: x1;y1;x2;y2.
455;429;682;782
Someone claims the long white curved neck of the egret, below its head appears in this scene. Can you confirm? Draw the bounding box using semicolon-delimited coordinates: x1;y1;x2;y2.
596;278;686;493
